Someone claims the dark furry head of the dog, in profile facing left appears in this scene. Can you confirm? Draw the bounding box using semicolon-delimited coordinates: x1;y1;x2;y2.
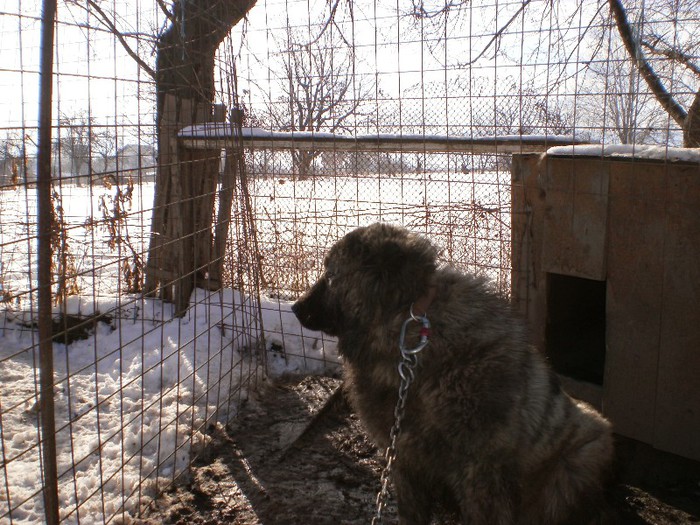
292;223;437;335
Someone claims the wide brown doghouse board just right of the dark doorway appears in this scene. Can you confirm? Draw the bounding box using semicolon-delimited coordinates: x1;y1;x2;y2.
603;162;665;443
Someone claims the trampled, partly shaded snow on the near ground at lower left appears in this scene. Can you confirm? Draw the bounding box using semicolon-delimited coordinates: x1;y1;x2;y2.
0;290;338;524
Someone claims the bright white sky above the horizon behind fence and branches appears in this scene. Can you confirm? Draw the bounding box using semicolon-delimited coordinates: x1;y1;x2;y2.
0;0;697;150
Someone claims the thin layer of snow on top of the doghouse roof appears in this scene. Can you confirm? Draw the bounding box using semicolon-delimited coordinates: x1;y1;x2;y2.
547;144;700;164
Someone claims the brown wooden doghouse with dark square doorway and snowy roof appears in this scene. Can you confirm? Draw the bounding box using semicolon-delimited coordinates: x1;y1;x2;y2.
512;146;700;460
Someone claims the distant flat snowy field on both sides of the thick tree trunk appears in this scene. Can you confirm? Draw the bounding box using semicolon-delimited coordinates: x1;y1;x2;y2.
0;171;510;300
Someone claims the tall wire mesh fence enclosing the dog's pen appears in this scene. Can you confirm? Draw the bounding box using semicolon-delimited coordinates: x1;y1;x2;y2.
0;0;700;523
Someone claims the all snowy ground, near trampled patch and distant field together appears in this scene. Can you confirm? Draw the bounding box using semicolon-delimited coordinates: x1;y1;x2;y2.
0;173;510;524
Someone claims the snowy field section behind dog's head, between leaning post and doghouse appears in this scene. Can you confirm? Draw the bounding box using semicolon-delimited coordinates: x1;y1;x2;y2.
252;171;510;296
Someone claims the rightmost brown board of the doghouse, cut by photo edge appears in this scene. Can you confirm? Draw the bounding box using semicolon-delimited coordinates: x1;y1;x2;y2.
653;167;700;460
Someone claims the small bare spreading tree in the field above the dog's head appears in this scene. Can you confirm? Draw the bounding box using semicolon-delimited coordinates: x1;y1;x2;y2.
267;29;375;177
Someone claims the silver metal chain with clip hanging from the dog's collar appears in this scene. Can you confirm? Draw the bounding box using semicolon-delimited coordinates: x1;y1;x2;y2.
372;305;430;525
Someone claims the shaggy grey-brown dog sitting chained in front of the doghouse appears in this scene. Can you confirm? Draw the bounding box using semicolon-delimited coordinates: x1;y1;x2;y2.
293;224;612;525
